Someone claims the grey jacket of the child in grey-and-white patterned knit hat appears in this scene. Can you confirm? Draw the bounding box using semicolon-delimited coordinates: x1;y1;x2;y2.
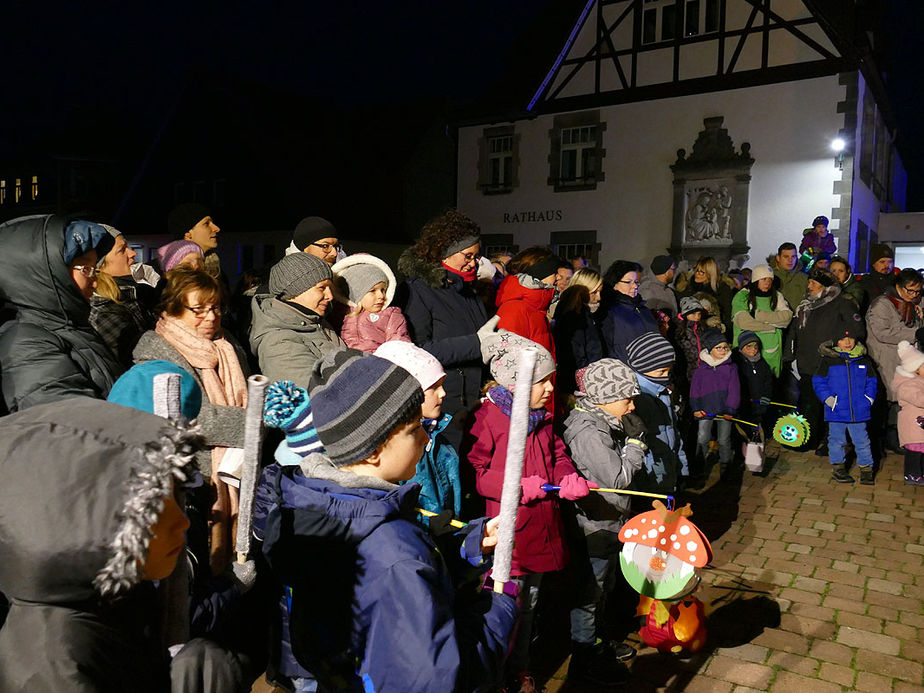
562;408;645;555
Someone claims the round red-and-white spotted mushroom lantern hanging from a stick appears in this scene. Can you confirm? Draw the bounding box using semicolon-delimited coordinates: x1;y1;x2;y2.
619;500;712;599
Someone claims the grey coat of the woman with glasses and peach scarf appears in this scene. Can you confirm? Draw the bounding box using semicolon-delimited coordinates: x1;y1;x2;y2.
132;330;249;478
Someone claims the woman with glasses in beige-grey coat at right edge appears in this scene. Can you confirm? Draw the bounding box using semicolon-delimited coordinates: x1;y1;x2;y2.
866;269;924;452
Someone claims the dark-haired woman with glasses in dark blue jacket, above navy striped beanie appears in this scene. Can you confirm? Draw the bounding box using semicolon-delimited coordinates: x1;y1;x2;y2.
601;260;660;363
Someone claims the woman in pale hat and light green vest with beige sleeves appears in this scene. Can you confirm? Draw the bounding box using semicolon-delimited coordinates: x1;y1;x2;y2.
732;265;792;377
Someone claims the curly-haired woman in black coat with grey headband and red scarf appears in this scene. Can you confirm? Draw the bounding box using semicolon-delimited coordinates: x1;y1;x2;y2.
396;210;498;448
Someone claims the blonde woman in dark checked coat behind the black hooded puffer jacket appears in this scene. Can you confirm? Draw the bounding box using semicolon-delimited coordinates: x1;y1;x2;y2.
90;224;157;368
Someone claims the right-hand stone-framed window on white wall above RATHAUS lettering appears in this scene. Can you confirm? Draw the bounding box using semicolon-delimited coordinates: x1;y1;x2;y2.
548;111;606;192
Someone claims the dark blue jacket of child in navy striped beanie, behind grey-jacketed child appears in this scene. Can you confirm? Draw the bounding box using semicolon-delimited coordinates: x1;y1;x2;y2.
633;373;690;493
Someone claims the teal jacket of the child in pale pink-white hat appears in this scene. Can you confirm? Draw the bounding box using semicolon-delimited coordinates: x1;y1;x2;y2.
411;414;462;524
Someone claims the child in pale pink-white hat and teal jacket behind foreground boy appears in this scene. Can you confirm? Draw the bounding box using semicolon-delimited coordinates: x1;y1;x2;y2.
375;340;462;525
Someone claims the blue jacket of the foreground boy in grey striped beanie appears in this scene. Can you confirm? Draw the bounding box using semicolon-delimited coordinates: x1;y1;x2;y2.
255;454;516;693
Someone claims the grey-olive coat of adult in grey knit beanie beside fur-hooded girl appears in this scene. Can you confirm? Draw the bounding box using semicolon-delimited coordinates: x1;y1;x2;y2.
250;294;346;389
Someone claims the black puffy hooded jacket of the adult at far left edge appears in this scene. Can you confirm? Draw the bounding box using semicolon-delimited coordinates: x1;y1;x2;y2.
0;215;125;411
